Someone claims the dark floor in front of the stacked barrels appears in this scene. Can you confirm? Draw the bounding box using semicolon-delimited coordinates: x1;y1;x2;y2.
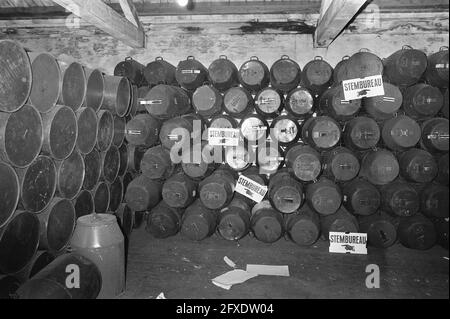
121;227;449;299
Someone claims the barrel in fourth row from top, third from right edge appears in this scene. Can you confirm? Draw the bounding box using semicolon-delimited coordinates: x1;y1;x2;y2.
360;149;400;185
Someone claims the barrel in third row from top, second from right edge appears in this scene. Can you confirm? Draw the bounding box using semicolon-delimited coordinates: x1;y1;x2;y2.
381;115;422;151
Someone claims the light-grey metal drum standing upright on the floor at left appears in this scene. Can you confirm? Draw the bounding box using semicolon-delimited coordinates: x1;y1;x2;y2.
70;214;125;299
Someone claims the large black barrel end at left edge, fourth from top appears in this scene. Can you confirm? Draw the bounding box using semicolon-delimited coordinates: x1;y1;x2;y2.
0;211;39;275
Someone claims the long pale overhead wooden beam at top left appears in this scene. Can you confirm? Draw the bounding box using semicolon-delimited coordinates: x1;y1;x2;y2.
53;0;145;48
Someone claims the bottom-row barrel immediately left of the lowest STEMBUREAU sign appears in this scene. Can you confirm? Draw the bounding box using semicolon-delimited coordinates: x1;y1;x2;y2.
285;205;320;246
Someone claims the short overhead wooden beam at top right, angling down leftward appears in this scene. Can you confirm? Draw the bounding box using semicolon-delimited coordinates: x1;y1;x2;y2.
314;0;367;47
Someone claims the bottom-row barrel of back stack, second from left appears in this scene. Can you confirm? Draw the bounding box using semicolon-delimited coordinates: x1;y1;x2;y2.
181;199;218;241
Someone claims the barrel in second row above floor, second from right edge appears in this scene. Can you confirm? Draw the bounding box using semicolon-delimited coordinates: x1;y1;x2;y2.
381;180;420;217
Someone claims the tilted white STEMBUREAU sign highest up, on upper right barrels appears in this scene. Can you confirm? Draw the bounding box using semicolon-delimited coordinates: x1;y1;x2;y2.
342;75;384;101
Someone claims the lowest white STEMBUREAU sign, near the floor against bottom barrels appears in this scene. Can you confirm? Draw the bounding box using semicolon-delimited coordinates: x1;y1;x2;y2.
329;232;367;255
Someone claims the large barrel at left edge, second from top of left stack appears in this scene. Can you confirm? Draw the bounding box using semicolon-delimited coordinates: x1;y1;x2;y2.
0;105;43;168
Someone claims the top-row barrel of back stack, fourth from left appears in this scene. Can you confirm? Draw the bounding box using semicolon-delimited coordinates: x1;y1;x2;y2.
208;55;239;92
